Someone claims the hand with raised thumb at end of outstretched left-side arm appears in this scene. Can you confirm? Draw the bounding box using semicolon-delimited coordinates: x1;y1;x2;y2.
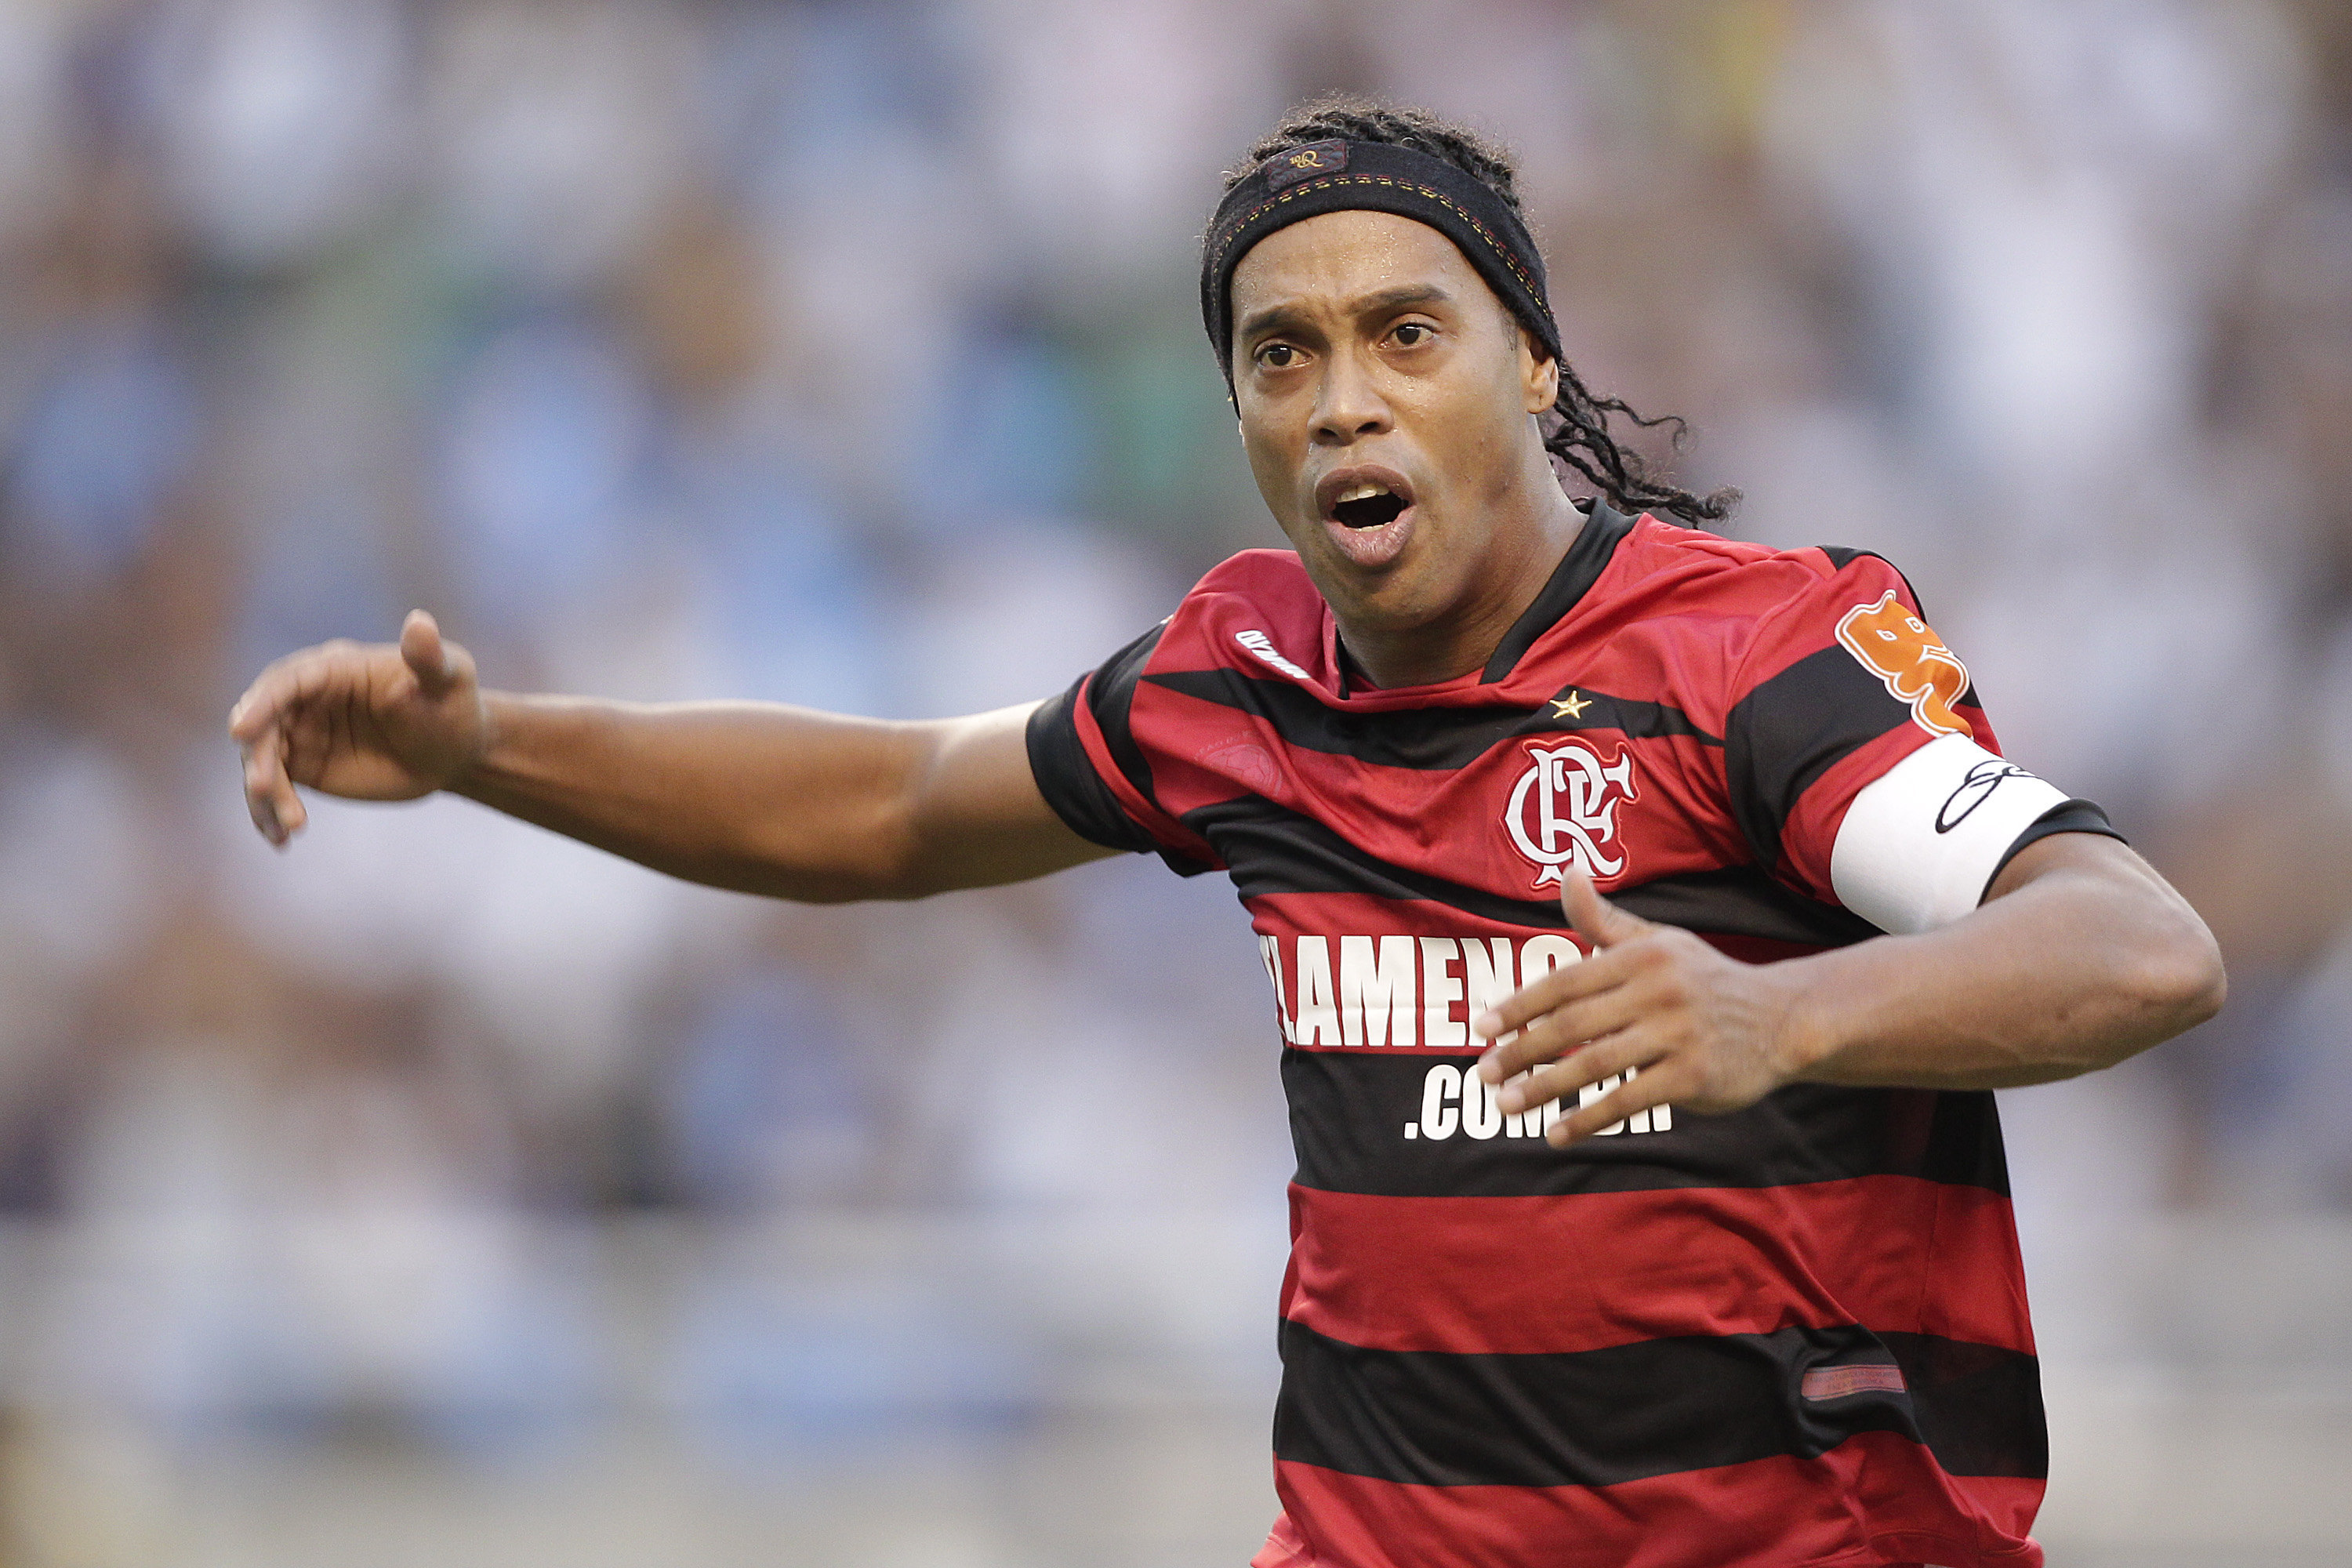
228;609;489;848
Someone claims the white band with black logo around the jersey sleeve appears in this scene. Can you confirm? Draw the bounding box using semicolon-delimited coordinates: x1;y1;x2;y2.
1830;736;2067;935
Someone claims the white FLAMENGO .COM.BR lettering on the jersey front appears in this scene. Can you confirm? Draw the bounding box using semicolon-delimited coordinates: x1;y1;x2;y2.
1258;933;1675;1138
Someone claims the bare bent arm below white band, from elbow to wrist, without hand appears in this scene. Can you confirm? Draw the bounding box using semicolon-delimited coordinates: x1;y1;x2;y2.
1776;832;2227;1088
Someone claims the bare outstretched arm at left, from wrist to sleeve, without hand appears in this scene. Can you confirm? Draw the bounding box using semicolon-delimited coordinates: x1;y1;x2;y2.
468;691;1112;902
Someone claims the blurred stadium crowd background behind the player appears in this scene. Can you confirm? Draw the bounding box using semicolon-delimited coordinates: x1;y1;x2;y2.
0;0;2352;1568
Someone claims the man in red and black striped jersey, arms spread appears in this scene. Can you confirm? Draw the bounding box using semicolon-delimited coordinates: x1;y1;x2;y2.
230;103;2223;1568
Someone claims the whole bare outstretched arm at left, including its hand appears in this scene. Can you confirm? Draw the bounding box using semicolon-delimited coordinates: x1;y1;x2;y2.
228;612;1112;902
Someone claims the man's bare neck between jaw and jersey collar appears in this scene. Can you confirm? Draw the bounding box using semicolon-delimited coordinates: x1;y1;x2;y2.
1334;456;1585;689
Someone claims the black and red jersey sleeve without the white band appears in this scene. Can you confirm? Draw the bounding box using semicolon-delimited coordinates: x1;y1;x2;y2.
1025;623;1216;877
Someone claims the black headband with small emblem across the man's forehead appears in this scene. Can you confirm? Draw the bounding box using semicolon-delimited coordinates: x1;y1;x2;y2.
1200;141;1559;393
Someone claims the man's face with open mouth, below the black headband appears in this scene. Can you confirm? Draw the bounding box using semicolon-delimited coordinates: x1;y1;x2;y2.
1232;212;1566;633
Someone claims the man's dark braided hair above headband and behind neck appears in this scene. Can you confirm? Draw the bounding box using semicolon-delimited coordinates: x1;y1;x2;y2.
1225;94;1740;522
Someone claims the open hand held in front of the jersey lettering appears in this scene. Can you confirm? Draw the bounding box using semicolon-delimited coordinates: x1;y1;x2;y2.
1470;872;1797;1147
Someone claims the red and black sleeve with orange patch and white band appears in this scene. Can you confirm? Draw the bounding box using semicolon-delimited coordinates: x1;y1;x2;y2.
1724;550;2119;931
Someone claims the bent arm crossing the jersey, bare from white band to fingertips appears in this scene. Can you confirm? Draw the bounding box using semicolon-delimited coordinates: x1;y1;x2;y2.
1475;832;2225;1145
